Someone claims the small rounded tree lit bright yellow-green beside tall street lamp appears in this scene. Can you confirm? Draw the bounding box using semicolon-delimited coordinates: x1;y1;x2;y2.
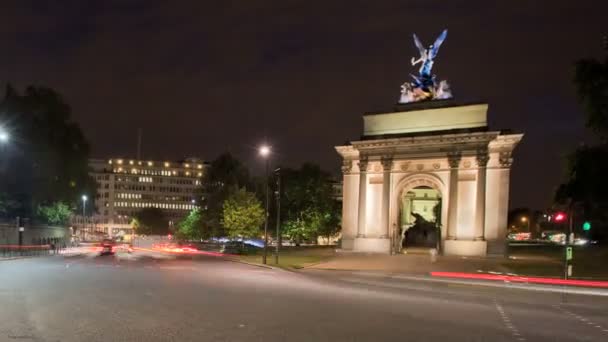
222;188;266;239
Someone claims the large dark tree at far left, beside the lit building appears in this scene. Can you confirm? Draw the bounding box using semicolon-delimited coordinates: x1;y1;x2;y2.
0;86;96;216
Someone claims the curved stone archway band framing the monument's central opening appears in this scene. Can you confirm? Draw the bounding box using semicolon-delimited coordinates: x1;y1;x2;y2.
389;172;447;246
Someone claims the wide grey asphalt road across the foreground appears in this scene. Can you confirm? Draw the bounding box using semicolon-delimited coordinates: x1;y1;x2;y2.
0;250;608;342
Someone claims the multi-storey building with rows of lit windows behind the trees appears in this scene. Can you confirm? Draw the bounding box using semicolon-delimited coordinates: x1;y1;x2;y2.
73;158;207;237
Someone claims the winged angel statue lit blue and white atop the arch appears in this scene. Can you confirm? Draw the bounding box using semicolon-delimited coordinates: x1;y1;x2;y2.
399;30;452;103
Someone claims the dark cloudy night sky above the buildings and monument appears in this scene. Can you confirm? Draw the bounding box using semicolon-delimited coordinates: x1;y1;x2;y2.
0;0;608;208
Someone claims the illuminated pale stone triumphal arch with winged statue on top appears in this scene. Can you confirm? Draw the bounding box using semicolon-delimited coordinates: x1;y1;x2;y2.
336;31;523;256
